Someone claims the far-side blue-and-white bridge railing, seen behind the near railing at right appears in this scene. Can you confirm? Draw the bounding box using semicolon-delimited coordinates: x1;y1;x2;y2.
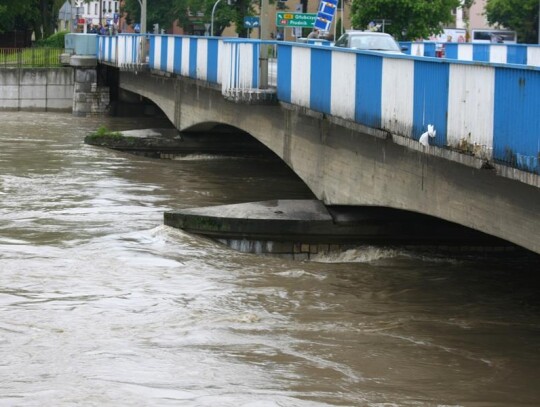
401;41;540;67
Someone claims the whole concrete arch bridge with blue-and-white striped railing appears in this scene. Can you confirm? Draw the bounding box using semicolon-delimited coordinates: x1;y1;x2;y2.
87;35;540;253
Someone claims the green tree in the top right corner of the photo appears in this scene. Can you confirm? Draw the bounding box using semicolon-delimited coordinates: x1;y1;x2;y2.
486;0;539;44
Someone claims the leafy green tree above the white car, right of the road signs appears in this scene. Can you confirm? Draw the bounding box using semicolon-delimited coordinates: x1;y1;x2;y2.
351;0;460;39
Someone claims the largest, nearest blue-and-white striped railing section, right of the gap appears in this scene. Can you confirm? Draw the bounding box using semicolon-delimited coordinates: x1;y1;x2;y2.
277;43;540;174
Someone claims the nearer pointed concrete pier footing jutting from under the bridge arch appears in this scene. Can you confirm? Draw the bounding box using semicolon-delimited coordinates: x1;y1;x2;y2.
164;200;511;258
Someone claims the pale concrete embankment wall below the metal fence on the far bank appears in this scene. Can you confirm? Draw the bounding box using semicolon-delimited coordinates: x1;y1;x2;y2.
0;68;74;112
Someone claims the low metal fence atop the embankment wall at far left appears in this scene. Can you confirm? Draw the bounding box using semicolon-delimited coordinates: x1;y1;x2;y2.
0;48;64;69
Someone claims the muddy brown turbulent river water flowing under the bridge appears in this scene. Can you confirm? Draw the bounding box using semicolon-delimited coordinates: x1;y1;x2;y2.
0;113;540;407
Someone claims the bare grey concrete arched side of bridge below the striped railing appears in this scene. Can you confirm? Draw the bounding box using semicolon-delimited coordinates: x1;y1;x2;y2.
120;72;540;253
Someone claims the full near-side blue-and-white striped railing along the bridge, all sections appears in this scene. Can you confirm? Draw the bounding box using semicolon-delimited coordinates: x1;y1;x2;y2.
95;35;540;174
